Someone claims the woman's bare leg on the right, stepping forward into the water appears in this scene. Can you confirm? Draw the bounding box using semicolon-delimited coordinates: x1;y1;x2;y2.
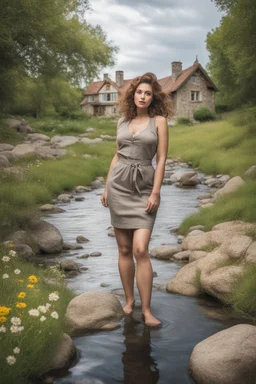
133;228;161;327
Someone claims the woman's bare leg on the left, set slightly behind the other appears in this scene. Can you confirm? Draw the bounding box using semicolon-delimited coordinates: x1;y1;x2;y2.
114;227;135;315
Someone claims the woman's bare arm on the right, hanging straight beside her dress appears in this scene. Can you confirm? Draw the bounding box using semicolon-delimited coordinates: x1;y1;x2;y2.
146;116;169;212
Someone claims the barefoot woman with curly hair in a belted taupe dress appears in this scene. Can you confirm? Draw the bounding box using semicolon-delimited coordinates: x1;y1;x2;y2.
101;72;171;327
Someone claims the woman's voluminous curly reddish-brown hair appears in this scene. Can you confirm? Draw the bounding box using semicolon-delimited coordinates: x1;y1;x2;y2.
118;72;173;120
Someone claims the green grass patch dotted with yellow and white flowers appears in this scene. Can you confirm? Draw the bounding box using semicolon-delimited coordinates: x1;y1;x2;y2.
0;246;74;384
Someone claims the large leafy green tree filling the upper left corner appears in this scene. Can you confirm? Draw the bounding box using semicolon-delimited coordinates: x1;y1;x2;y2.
0;0;117;111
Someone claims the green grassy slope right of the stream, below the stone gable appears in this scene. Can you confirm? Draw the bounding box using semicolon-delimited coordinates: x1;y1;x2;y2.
168;112;256;235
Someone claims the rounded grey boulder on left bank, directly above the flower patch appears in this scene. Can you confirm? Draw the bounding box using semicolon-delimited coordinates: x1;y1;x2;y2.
27;219;63;253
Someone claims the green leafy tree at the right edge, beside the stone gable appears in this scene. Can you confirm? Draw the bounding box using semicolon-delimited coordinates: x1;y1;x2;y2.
206;0;256;105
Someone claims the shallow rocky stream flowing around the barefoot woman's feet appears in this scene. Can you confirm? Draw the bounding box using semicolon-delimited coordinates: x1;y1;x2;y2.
44;167;241;384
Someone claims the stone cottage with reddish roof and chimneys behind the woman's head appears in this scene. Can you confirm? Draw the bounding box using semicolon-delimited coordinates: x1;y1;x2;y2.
80;59;218;118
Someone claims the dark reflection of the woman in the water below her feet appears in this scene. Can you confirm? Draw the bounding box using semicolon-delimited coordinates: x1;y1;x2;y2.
122;316;160;384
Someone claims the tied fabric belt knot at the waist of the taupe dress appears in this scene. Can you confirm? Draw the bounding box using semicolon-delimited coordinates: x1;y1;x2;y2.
119;158;152;196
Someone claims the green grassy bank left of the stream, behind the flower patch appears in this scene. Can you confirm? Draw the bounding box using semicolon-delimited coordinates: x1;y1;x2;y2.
0;115;116;237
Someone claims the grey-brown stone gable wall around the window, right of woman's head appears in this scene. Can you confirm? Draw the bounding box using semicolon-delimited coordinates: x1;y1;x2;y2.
175;71;215;118
